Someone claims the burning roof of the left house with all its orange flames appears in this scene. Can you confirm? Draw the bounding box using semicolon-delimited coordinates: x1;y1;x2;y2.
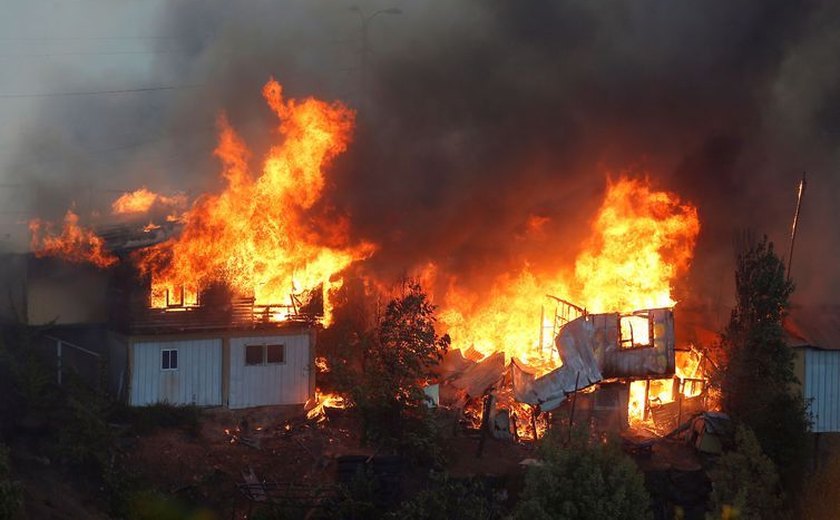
31;80;373;321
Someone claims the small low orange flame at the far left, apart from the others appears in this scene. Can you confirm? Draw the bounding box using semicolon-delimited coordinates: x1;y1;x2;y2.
29;210;117;268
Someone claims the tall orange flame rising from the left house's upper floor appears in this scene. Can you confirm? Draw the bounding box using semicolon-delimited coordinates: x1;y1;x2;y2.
137;80;373;321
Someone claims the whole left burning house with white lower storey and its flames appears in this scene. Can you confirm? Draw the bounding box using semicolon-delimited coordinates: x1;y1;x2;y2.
4;81;371;408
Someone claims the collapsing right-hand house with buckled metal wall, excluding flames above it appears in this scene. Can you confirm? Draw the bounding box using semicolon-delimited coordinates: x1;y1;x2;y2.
434;300;713;438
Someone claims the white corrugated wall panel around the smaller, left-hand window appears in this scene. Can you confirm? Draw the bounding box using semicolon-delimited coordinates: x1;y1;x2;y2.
130;338;222;406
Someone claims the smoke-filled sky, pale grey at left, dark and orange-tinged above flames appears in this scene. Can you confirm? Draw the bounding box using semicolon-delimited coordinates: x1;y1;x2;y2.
0;0;840;312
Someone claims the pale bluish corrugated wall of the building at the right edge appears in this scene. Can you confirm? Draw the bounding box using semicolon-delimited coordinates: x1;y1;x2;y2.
804;349;840;432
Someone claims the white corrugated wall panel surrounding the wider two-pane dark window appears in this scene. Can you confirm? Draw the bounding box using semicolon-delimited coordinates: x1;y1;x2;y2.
228;334;312;408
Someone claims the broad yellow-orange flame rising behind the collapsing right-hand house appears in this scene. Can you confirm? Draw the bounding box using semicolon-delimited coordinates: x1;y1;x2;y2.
440;176;700;374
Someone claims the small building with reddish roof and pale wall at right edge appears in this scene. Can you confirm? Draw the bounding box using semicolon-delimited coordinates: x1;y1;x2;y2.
784;305;840;433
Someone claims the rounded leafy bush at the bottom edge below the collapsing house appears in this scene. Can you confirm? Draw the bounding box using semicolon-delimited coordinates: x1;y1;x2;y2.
513;433;651;520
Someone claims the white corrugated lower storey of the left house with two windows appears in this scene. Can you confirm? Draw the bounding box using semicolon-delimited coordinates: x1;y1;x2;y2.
119;323;315;408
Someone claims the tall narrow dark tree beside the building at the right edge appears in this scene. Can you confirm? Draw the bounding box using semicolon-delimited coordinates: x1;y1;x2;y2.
718;237;808;482
